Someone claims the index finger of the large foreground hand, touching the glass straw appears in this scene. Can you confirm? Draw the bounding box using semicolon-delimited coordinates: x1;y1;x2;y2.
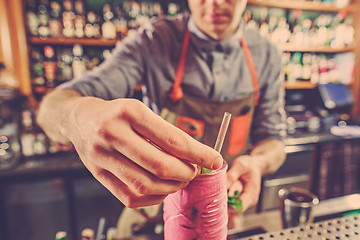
125;100;223;169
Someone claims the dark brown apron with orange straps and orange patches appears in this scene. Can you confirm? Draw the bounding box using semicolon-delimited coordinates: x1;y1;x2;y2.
160;31;259;165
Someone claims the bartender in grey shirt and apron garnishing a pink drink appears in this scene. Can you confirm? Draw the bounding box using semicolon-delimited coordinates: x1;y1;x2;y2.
37;0;285;233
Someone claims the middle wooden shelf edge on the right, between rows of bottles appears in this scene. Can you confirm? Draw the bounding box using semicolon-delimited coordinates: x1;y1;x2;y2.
277;43;355;53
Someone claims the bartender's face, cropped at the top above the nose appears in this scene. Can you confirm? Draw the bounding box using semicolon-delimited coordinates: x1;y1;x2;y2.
188;0;247;40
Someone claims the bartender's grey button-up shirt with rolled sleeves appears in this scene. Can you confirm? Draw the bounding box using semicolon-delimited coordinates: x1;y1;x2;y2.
60;13;286;143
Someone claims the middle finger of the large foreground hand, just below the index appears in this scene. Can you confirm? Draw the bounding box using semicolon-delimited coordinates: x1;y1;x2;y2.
102;120;197;182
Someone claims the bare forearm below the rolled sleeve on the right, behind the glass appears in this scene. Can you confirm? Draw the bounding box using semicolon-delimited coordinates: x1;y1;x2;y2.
250;139;286;175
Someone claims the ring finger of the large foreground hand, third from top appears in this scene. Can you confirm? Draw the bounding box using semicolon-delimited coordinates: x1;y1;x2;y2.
93;144;188;195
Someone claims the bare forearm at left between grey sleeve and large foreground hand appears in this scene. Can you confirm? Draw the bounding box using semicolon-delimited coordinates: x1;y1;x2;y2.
37;89;81;144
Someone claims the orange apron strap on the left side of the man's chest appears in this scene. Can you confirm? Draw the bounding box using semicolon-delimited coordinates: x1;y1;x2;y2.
169;30;190;102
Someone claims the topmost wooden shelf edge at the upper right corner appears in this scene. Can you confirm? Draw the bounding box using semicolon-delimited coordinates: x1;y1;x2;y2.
248;0;358;13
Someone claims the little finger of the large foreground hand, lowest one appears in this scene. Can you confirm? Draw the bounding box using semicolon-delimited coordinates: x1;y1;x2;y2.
94;166;166;208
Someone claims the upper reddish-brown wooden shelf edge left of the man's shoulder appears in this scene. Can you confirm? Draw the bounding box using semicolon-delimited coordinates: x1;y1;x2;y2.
29;37;119;47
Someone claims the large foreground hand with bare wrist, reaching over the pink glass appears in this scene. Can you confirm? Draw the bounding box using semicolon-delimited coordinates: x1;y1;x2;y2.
38;90;223;208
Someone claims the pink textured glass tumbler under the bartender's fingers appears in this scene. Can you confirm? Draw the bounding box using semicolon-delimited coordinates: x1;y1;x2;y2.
164;162;228;240
